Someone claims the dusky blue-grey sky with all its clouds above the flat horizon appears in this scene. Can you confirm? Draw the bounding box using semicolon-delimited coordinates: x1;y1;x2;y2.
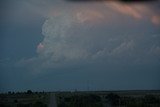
0;0;160;92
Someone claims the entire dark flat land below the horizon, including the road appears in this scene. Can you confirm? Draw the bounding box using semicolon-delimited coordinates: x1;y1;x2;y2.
0;91;160;107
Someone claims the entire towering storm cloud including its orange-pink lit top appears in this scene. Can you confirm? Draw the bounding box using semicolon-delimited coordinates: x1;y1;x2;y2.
17;1;160;72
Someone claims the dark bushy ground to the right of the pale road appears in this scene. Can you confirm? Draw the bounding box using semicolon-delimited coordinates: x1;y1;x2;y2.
57;91;160;107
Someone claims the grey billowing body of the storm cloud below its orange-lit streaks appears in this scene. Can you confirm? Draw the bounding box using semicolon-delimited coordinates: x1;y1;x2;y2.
15;0;160;70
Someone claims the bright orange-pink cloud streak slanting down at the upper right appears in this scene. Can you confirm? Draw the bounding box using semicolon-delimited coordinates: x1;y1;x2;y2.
105;2;160;25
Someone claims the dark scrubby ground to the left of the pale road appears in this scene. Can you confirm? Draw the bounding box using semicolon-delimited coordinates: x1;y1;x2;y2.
0;90;49;107
